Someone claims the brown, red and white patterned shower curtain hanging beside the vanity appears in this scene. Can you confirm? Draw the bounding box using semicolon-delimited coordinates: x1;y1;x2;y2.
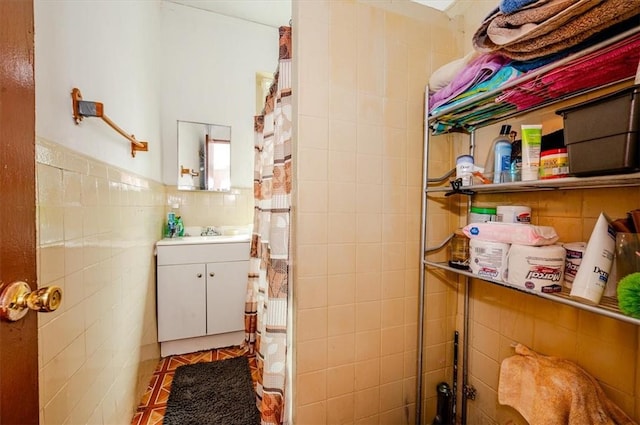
245;27;292;425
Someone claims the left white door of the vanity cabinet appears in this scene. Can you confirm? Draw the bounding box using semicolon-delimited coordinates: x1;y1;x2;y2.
158;264;207;341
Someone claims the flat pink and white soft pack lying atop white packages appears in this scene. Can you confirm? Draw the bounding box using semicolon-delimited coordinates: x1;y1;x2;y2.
462;221;559;246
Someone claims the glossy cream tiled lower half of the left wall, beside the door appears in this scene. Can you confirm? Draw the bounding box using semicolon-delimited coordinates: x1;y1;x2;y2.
36;139;166;425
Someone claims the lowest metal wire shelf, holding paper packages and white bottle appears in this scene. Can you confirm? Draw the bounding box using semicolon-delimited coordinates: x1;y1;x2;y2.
424;260;640;325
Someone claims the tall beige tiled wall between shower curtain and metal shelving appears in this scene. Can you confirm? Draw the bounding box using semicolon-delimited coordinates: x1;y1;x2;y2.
293;1;455;424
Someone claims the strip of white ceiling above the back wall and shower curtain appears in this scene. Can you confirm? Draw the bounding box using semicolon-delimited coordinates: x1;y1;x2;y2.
165;0;291;28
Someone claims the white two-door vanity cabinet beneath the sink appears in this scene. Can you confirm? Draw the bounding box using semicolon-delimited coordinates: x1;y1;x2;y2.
157;238;249;357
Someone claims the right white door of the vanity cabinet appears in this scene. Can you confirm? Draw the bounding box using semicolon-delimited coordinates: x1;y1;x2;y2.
207;261;249;335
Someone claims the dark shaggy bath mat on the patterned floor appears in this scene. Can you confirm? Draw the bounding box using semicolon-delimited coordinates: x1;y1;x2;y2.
163;356;260;425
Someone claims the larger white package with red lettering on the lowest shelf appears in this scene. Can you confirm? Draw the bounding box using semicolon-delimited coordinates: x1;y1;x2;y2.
507;244;566;293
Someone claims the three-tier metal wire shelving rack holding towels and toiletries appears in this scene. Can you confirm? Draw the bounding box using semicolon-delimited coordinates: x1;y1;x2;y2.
416;25;640;423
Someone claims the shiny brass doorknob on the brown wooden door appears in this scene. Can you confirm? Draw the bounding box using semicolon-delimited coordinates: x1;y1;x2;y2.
0;281;62;322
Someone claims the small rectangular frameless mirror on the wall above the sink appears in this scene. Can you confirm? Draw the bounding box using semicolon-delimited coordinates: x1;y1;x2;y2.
178;121;231;191
